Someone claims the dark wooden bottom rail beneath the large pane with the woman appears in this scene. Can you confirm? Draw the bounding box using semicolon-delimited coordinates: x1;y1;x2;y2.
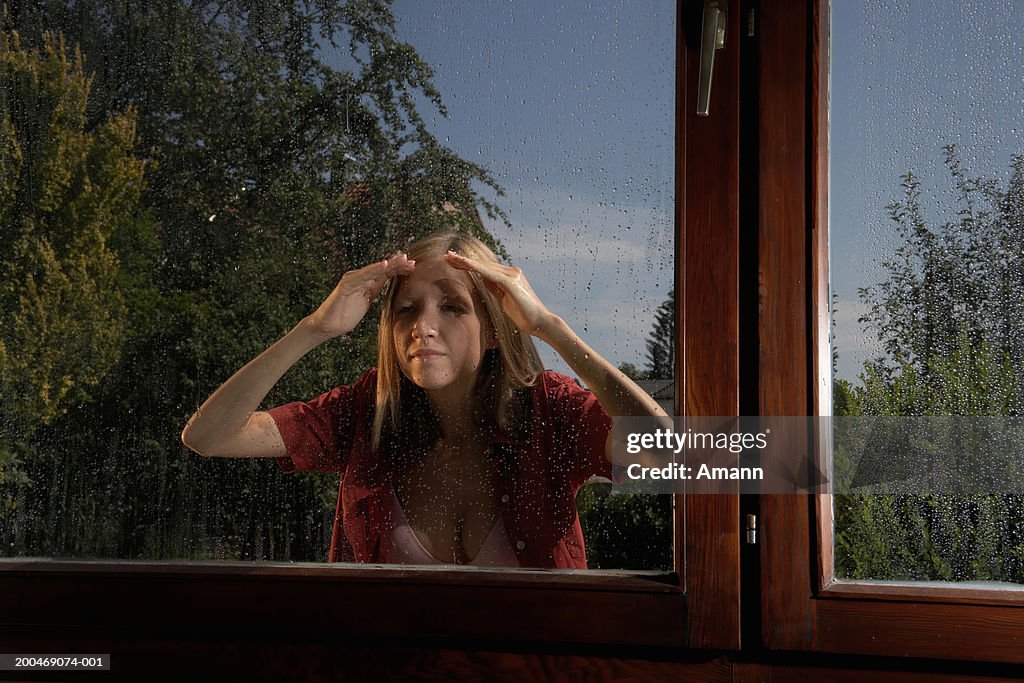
0;559;687;647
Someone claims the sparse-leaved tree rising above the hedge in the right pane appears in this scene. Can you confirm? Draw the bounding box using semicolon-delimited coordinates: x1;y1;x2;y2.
860;145;1024;415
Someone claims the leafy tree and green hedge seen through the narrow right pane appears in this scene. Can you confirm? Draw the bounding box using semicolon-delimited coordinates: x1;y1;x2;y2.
834;146;1024;583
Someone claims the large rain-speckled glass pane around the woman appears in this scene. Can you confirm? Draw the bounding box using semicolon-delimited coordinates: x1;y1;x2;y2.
0;0;676;568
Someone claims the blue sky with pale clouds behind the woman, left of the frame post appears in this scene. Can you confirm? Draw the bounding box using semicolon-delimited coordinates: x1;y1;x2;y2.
329;0;676;375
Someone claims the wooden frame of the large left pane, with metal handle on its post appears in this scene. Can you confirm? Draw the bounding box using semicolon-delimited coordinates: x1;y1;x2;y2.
0;0;739;649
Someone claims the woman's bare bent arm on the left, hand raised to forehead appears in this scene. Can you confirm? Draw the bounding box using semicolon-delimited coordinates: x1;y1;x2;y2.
181;255;415;458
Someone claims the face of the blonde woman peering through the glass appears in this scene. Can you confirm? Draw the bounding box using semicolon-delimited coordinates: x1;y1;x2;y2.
392;257;486;401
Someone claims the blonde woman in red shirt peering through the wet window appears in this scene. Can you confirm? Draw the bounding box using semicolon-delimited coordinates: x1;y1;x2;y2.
181;232;665;568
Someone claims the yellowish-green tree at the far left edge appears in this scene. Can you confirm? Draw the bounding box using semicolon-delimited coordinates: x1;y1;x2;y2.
0;32;152;511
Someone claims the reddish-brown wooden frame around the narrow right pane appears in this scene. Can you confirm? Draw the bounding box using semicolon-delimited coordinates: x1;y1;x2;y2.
751;0;1024;664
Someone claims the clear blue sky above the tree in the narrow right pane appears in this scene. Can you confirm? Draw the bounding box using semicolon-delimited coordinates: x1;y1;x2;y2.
829;0;1024;380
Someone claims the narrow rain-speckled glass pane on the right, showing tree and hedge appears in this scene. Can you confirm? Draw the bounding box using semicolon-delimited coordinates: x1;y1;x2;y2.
829;1;1024;583
